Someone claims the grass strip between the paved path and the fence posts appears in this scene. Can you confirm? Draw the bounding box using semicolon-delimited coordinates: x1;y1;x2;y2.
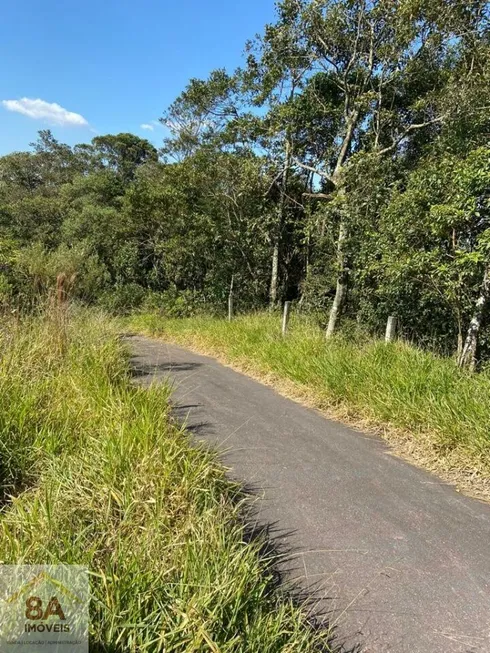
131;314;490;499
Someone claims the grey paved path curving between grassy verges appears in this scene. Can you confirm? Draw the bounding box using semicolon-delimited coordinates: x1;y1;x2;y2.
130;337;490;653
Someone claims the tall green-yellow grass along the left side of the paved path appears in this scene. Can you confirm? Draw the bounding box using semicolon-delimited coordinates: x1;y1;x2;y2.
0;311;330;653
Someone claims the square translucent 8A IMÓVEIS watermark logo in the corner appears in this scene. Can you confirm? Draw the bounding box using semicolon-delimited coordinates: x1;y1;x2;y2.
0;565;90;653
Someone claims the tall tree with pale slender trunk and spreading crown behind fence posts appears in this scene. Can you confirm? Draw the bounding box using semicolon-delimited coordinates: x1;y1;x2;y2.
264;0;486;335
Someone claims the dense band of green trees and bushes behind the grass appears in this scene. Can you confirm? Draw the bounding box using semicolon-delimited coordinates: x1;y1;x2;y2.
0;0;490;367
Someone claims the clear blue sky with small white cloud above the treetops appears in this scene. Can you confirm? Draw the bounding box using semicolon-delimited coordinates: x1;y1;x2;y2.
0;0;274;154
